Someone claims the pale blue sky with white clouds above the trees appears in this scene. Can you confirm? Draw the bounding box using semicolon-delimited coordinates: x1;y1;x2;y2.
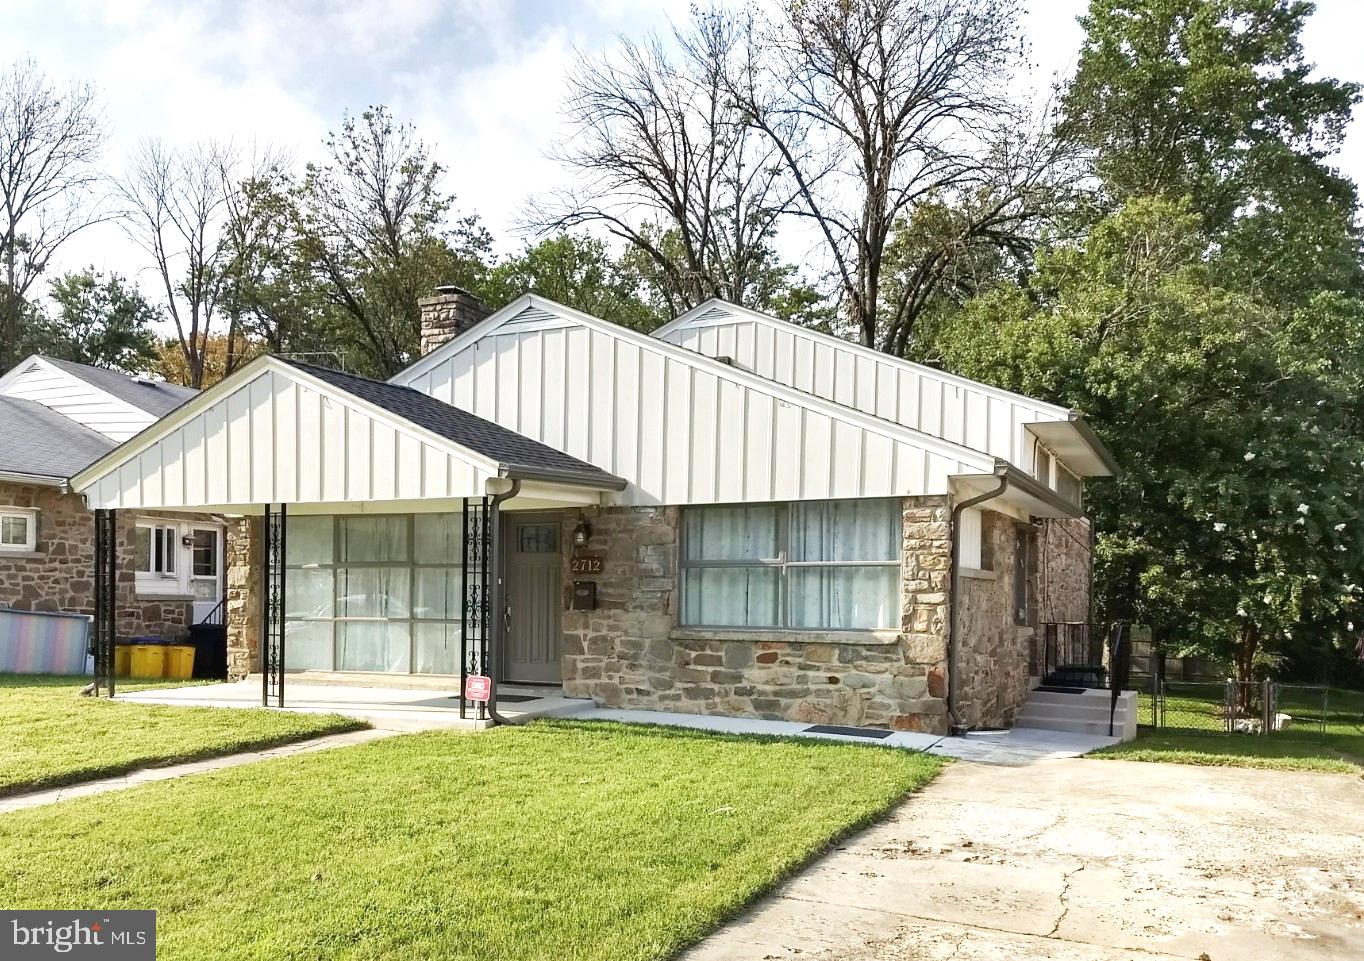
8;0;1364;299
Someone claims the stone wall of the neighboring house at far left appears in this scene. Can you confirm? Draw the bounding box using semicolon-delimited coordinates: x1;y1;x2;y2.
0;484;192;638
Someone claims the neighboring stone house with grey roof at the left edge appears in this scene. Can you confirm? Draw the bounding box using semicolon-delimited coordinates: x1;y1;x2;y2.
0;356;225;637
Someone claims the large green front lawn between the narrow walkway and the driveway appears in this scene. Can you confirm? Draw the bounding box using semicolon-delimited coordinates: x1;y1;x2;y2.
0;721;941;961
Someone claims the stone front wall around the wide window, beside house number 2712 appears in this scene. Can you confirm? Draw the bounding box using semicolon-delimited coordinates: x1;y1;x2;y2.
563;498;951;732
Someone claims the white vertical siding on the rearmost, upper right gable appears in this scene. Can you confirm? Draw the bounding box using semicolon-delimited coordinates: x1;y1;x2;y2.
656;304;1068;470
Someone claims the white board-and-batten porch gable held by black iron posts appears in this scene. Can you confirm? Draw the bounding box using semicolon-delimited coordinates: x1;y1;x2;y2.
85;367;496;508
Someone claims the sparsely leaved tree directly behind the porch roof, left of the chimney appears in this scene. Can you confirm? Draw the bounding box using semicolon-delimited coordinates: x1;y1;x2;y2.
296;106;491;376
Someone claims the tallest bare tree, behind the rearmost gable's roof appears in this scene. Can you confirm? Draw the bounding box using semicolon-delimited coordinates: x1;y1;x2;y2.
732;0;1068;354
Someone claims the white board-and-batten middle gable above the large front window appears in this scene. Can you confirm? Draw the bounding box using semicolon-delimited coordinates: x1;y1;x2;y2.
394;299;993;504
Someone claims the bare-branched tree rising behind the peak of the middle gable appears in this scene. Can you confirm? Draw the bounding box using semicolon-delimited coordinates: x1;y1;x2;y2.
532;11;797;315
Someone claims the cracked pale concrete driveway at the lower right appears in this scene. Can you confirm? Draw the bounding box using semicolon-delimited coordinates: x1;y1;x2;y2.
683;759;1364;961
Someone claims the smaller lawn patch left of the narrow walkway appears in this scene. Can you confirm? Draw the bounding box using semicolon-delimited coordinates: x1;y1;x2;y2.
0;675;366;796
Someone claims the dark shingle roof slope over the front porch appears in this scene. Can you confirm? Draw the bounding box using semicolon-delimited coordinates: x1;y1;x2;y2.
278;357;625;488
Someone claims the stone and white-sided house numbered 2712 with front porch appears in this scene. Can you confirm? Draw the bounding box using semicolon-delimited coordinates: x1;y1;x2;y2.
72;288;1116;732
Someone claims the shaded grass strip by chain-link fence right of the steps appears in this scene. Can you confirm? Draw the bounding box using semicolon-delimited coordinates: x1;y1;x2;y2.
1090;684;1364;774
